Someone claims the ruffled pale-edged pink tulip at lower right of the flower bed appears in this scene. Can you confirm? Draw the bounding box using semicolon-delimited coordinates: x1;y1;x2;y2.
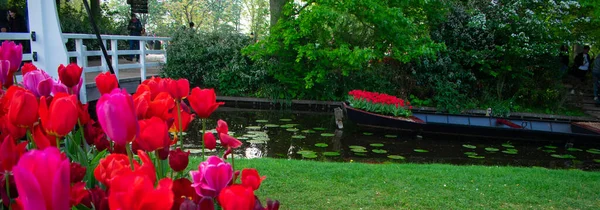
190;156;233;198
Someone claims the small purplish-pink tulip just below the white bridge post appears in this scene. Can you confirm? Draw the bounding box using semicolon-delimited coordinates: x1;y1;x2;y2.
21;70;54;98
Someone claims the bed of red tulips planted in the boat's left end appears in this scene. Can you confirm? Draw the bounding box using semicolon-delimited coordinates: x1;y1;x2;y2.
348;90;412;117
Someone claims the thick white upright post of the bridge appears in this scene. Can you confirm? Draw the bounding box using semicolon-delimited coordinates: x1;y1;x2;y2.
27;0;68;79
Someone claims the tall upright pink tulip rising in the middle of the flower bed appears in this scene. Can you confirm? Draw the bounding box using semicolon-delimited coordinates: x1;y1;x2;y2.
96;89;140;146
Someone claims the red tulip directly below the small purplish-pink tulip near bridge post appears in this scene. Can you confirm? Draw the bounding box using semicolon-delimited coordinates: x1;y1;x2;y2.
40;93;79;137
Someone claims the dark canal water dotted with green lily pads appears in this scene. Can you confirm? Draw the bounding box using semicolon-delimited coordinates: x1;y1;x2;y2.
186;107;600;171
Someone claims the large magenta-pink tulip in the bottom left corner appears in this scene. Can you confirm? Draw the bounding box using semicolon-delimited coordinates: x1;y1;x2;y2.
13;147;71;210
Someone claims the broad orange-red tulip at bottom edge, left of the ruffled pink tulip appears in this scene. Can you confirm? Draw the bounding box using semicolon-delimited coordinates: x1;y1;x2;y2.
108;174;174;210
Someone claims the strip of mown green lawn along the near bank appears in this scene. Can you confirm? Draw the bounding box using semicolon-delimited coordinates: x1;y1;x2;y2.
190;158;600;209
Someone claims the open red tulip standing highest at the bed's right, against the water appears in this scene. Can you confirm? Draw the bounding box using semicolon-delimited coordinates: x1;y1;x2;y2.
188;87;225;119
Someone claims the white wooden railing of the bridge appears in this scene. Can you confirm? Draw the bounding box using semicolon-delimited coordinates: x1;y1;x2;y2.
0;33;171;103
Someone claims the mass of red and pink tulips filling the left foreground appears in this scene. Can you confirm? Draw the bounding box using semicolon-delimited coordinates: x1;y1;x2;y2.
0;42;279;210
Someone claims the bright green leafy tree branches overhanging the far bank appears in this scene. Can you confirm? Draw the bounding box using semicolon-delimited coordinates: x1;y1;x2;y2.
244;0;442;99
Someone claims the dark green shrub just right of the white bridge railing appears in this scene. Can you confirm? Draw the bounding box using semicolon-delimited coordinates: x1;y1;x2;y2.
163;29;266;95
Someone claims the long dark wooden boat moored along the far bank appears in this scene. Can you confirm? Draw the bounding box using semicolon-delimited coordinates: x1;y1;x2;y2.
343;103;600;143
